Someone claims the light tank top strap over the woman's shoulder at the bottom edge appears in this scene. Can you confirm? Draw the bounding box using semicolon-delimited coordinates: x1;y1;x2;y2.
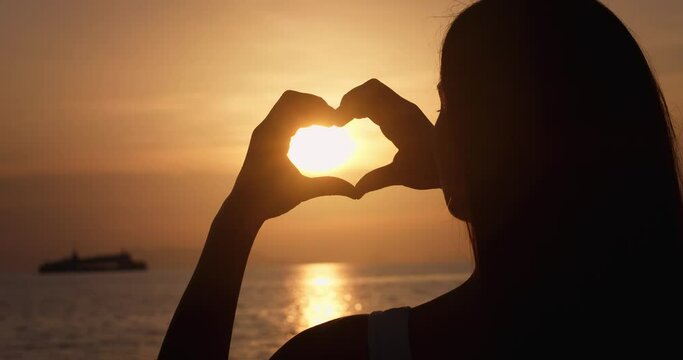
368;307;411;360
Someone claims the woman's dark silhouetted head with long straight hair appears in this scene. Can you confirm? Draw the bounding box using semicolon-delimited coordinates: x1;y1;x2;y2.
436;0;683;357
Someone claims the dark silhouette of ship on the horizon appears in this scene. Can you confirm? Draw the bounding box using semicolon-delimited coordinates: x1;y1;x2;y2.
38;251;147;273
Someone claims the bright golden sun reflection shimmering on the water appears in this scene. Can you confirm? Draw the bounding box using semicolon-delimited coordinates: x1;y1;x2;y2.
298;263;351;331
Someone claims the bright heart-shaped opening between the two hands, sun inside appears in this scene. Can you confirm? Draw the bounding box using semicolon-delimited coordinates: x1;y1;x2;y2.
287;118;398;183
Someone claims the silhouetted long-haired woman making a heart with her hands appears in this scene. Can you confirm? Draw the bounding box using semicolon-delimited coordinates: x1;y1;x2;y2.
160;0;682;359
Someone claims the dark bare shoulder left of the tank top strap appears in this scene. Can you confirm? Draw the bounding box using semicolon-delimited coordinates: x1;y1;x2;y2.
271;315;368;360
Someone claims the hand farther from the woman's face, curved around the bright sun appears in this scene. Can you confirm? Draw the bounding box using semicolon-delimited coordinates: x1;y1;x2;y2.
229;90;358;221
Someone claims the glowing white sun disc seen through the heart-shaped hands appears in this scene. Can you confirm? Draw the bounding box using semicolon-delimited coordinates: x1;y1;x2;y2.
287;125;356;176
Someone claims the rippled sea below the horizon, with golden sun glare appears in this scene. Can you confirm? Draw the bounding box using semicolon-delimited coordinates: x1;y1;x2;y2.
0;263;469;360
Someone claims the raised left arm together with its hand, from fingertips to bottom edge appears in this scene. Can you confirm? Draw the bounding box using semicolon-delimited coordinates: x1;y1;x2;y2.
159;91;356;359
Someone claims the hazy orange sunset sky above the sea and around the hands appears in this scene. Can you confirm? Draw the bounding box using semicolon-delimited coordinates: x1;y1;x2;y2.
0;0;683;271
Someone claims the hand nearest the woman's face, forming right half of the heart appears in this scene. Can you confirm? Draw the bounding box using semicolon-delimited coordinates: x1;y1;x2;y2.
337;79;439;196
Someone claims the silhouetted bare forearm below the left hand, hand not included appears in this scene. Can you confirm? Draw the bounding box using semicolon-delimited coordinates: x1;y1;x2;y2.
159;196;261;359
